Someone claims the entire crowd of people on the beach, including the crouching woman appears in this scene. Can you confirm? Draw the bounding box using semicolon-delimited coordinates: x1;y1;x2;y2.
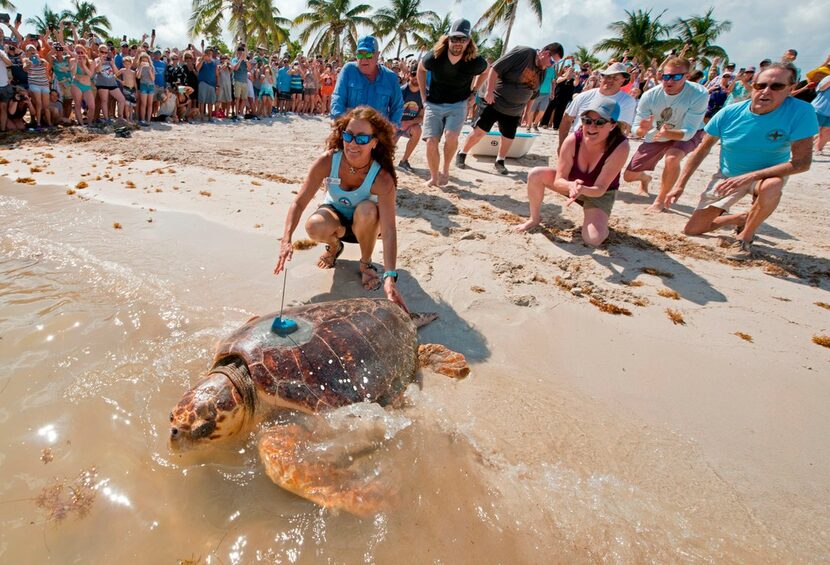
0;13;830;309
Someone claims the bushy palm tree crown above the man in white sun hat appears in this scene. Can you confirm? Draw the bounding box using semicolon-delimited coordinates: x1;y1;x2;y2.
594;10;671;61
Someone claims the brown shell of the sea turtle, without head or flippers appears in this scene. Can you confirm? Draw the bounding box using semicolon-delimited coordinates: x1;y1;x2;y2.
214;298;418;412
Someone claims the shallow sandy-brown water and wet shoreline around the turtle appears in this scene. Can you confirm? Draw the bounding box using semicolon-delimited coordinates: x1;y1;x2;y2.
0;187;816;563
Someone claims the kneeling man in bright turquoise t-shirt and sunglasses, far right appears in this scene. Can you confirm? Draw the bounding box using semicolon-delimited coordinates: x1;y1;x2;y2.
667;63;818;260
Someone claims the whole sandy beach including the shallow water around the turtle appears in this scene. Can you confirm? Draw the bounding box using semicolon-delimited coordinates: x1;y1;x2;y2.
0;117;830;563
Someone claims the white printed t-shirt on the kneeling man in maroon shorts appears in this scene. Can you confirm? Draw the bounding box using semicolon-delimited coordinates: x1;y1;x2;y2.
635;81;709;142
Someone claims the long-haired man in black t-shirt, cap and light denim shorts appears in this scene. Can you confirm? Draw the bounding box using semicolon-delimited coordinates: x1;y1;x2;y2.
418;19;487;186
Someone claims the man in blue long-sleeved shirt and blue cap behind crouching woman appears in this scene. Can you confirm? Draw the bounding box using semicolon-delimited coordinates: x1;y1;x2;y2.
331;35;403;128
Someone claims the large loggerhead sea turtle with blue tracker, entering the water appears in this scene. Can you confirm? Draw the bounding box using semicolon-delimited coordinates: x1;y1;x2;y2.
170;298;469;515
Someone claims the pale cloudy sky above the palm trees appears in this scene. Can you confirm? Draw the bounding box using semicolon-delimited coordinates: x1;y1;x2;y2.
12;0;830;70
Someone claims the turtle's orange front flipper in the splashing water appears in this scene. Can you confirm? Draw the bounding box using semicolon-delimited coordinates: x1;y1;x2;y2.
259;423;399;517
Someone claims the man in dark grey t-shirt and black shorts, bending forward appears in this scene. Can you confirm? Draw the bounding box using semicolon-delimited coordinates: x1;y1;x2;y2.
455;43;562;175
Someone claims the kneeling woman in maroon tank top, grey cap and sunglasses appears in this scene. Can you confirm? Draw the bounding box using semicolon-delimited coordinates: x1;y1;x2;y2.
516;98;629;246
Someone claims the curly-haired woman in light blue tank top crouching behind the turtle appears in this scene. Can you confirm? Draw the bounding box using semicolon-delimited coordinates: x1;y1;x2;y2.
274;106;408;311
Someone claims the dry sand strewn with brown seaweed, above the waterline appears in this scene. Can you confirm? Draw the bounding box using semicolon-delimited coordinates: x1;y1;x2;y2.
0;118;830;558
